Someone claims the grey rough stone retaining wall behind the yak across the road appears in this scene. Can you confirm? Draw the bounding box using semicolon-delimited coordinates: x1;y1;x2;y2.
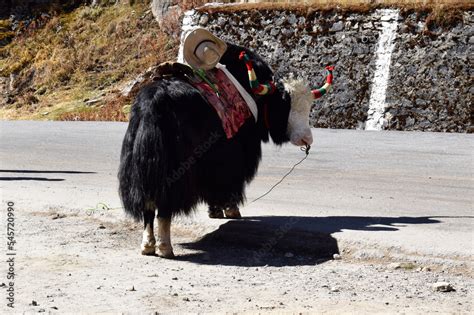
184;10;474;132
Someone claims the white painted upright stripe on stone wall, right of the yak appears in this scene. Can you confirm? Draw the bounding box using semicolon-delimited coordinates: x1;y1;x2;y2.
365;9;398;130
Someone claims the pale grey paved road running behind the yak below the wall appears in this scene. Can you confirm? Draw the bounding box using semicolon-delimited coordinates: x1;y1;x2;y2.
0;121;474;262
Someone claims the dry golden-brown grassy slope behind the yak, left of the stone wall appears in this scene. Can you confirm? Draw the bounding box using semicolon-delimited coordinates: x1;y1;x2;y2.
0;4;178;120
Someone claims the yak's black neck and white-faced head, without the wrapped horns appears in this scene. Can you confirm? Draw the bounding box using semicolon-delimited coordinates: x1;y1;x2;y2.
220;43;313;146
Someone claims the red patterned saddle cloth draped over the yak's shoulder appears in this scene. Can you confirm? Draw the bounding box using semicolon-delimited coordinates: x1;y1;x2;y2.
192;69;252;139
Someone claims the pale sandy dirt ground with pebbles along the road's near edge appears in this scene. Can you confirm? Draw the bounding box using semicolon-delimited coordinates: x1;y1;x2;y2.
0;209;473;314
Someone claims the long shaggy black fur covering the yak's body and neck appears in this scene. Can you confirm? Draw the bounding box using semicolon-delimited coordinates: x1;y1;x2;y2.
118;44;291;220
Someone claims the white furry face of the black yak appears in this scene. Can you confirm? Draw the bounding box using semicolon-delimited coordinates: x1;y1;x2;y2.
283;79;313;146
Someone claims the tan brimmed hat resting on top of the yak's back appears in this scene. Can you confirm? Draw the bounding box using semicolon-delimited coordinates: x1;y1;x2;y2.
183;28;227;70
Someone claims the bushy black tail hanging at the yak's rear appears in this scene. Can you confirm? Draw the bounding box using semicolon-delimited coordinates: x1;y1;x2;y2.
118;93;164;221
